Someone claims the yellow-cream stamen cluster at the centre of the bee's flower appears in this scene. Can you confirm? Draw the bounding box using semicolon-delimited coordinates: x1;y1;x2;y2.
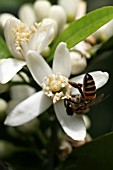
42;73;71;103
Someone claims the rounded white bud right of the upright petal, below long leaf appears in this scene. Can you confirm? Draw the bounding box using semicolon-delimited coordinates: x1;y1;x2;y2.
70;51;87;75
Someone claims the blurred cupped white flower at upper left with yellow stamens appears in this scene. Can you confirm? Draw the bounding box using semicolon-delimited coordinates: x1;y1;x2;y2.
0;18;54;84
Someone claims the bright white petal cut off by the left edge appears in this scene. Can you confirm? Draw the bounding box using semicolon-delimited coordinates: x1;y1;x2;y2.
0;58;26;84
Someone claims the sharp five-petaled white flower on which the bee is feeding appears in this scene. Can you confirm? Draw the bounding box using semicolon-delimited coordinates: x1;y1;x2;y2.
5;42;108;140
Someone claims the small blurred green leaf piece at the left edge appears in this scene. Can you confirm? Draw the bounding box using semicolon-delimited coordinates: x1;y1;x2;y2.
0;36;11;59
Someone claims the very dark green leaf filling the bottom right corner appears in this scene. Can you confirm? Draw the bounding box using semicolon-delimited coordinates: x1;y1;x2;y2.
60;133;113;170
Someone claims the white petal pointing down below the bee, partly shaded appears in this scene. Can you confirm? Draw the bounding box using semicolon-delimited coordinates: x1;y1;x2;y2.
54;101;86;140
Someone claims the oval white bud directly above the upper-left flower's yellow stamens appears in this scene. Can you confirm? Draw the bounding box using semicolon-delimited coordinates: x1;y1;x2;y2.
18;4;36;26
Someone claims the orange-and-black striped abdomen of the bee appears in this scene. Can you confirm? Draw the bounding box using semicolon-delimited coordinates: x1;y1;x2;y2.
83;74;96;100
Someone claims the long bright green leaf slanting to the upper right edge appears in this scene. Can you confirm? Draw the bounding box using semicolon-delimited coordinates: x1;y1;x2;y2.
47;6;113;62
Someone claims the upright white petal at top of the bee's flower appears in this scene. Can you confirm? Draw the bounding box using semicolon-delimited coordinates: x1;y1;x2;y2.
53;42;71;77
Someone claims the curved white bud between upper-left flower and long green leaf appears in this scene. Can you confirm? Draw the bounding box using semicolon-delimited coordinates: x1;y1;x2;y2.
48;5;66;34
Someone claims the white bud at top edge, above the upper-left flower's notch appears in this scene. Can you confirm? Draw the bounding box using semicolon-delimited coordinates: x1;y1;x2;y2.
34;0;51;22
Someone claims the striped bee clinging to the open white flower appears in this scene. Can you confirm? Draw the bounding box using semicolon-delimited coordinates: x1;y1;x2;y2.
64;73;104;115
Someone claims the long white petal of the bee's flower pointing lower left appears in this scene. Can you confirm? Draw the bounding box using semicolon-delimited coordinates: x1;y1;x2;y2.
4;91;52;126
